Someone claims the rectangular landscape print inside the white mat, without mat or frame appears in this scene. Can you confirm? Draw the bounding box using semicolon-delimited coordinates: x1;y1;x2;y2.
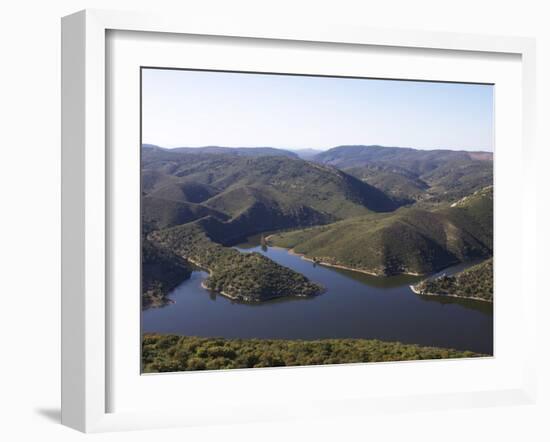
140;68;494;373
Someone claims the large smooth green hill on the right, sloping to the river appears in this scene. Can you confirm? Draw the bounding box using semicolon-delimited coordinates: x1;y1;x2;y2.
269;188;493;275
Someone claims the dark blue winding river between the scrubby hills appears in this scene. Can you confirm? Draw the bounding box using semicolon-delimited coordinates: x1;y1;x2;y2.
141;237;493;354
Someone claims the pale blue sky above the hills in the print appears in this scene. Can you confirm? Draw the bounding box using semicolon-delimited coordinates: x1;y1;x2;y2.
142;68;494;151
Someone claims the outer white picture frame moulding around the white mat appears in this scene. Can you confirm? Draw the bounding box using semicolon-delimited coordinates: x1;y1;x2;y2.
62;10;537;432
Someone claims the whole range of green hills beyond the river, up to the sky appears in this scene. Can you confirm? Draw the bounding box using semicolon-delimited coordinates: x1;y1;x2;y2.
142;146;492;305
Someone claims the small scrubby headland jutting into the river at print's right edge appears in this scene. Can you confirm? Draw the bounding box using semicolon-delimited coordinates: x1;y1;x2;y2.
414;258;493;302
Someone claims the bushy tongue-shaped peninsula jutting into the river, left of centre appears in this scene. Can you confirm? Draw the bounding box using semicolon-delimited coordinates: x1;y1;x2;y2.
149;223;322;302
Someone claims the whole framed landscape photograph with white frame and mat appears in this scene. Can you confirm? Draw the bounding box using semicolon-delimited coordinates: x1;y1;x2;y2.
62;11;536;432
